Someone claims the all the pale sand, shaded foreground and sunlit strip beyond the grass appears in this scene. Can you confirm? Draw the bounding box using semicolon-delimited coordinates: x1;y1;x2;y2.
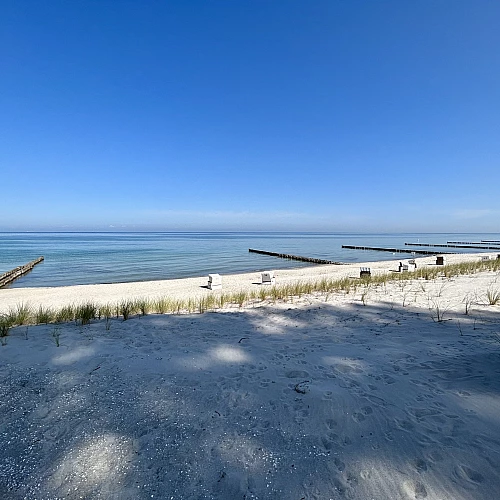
0;253;500;500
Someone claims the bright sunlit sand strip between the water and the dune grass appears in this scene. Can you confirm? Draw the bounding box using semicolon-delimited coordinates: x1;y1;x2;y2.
0;252;497;313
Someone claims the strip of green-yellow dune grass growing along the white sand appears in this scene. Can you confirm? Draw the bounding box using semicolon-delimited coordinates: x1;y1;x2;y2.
0;259;500;330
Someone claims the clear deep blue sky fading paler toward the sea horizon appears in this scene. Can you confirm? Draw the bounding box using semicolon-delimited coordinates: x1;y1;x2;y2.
0;0;500;232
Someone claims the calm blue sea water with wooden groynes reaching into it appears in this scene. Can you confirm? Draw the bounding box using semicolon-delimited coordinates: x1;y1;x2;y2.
0;232;500;288
